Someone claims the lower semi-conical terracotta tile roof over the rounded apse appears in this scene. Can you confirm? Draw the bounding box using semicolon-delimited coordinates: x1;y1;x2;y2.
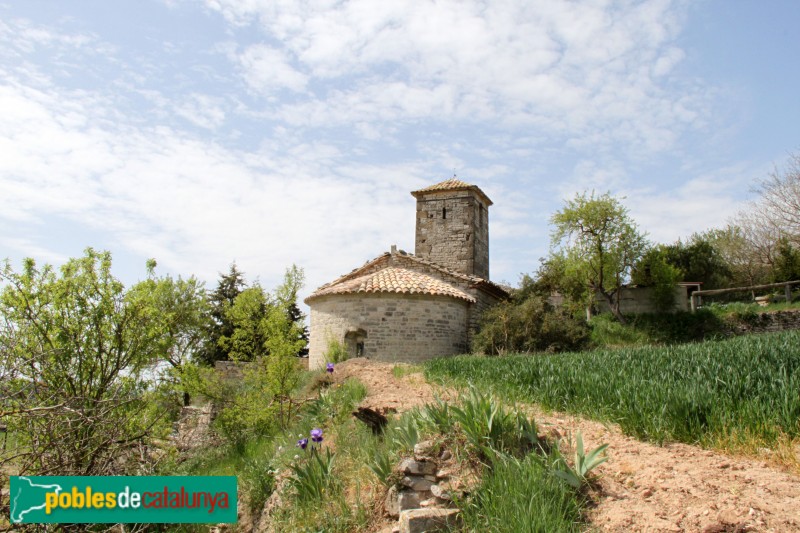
306;266;468;303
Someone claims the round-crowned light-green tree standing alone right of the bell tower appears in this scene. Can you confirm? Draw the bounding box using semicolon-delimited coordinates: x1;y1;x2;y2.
551;192;647;323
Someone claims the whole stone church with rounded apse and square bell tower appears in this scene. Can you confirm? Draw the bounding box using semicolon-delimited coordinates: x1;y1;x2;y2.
305;176;508;368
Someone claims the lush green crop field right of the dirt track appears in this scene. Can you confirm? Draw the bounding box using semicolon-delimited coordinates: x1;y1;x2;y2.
425;331;800;447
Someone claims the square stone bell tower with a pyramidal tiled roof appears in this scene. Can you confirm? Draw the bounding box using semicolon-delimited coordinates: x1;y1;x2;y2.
411;176;492;280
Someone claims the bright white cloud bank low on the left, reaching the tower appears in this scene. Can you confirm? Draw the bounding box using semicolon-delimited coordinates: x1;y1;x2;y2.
0;68;424;296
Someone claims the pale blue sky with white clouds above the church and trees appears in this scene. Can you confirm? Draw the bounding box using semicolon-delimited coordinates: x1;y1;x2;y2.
0;0;800;308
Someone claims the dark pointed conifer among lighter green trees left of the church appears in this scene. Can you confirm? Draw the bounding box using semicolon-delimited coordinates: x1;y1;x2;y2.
196;263;245;366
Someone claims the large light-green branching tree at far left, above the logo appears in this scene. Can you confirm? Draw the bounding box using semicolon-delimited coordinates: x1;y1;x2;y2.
0;248;163;475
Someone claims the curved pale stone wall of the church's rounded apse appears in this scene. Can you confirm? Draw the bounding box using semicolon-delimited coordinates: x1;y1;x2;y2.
309;293;470;369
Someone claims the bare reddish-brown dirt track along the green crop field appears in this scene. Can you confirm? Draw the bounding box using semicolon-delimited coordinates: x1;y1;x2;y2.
335;359;800;533
